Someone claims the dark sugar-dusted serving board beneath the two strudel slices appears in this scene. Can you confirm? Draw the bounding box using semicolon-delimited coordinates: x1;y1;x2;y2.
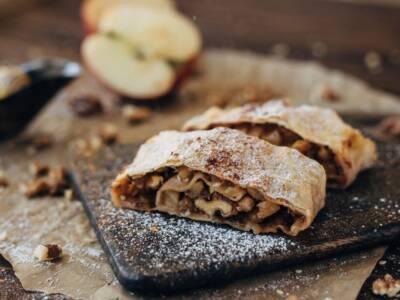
72;135;400;292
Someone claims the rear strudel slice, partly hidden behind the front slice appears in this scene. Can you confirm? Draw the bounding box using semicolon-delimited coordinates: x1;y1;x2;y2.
183;100;377;188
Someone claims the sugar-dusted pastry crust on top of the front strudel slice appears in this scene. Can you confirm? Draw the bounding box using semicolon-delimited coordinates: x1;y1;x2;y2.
122;128;326;233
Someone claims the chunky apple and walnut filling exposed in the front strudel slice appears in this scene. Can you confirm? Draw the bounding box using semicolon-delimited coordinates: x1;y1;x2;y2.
116;167;294;233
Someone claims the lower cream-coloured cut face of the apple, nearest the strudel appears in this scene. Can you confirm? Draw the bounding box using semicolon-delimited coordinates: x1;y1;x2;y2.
81;33;176;100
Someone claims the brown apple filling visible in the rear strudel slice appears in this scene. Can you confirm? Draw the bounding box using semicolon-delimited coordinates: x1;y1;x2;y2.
232;124;345;184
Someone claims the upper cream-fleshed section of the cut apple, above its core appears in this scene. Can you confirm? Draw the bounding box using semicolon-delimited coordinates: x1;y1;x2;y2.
99;5;201;63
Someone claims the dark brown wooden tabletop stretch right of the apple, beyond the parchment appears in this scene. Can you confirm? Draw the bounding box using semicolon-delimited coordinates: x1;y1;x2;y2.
178;0;400;93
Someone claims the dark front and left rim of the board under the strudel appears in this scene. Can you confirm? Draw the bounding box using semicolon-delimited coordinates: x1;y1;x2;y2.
70;174;400;294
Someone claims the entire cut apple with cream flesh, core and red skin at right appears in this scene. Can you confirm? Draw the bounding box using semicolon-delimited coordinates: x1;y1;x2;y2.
81;4;201;100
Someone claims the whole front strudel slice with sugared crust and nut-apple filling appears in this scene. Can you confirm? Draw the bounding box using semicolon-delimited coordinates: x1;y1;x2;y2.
112;128;326;235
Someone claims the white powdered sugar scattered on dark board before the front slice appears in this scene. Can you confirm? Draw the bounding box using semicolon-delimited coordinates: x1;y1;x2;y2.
99;200;295;273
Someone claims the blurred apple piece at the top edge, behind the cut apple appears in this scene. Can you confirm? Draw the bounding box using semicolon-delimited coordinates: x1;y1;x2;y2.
81;0;174;34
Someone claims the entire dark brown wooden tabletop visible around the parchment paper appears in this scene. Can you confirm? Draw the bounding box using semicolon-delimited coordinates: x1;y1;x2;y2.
0;0;400;298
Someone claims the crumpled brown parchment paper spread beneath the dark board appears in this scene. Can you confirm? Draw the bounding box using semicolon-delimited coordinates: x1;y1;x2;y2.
0;50;400;299
